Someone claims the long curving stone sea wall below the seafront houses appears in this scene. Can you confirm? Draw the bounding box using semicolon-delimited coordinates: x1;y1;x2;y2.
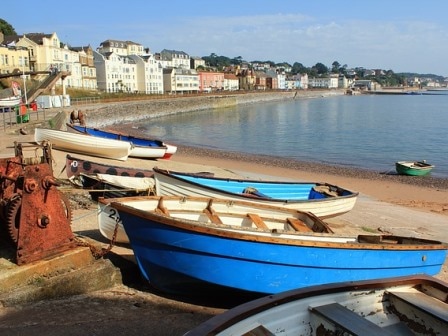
81;90;344;127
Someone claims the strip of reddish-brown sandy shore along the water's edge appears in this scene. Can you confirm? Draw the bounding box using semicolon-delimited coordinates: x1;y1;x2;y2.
170;146;448;216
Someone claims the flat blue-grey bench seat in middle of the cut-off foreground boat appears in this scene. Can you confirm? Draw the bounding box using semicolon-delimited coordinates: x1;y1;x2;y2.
310;303;392;336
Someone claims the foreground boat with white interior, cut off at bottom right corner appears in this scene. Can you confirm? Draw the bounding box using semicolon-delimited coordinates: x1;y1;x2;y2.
185;275;448;336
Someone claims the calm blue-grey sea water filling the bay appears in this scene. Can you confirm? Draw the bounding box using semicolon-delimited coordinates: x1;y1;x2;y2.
138;91;448;178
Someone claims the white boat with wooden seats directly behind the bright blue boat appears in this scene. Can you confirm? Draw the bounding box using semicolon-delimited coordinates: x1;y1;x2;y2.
98;196;333;243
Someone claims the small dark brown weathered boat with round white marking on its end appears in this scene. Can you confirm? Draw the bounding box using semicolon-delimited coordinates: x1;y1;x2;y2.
65;154;154;178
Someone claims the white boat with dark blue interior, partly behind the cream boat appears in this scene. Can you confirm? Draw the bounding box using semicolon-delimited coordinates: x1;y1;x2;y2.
67;124;177;159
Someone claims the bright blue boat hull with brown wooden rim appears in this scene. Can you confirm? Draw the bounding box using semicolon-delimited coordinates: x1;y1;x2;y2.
111;198;446;295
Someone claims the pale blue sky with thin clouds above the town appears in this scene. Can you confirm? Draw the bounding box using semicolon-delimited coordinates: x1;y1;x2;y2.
0;0;448;76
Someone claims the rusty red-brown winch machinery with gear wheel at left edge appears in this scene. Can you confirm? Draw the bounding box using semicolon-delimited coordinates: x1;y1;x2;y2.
0;142;77;265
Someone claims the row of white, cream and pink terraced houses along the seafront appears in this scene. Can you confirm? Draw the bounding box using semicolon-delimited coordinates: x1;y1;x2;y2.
0;33;351;94
